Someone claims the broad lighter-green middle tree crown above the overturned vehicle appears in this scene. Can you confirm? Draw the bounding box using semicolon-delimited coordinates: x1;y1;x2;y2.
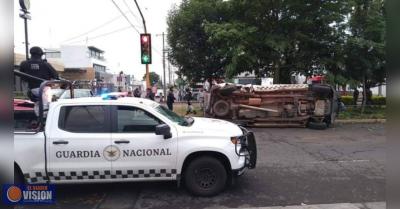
206;0;348;83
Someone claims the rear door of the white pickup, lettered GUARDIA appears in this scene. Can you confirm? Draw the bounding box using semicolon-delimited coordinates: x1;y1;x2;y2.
47;105;111;182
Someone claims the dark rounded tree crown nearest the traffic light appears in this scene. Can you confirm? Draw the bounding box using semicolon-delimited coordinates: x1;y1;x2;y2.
167;0;225;82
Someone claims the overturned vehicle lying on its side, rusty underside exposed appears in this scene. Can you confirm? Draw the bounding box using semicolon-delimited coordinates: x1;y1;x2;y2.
204;83;339;129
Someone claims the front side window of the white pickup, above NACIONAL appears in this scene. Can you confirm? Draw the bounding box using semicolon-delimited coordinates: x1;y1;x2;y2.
117;106;161;133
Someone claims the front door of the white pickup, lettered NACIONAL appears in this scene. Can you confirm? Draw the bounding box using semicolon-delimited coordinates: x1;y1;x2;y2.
111;106;177;180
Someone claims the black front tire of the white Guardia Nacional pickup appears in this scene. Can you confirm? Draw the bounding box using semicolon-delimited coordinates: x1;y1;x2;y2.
183;156;228;197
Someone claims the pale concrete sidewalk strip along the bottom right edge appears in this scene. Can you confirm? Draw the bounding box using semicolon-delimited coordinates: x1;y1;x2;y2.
234;202;386;209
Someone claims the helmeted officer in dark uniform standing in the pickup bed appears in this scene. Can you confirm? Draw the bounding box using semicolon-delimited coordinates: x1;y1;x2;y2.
20;46;59;101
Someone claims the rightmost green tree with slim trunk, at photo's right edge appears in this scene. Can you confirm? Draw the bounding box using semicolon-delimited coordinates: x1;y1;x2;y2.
345;0;386;109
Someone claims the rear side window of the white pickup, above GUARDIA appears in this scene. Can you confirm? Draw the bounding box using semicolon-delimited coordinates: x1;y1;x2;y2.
58;106;109;133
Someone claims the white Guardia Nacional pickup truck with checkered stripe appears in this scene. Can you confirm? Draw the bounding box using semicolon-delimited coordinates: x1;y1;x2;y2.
14;86;257;196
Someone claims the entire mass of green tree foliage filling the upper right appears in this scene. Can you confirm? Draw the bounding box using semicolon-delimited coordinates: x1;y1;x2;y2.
168;0;385;83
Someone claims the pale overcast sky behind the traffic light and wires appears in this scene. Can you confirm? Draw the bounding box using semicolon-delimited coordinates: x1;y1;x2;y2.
14;0;181;80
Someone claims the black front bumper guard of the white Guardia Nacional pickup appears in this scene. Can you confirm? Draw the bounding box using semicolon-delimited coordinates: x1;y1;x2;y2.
235;127;257;171
